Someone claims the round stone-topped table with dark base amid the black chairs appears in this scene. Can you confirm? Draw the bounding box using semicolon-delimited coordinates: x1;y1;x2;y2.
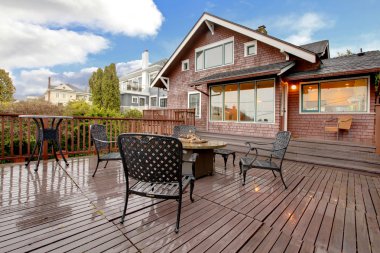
181;140;226;178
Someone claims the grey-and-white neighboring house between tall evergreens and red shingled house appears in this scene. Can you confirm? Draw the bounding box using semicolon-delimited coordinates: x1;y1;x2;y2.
119;50;167;111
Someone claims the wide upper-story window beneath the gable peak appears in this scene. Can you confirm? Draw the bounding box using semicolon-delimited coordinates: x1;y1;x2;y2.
195;37;234;71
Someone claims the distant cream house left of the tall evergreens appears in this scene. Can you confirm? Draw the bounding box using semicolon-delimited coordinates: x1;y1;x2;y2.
44;77;91;105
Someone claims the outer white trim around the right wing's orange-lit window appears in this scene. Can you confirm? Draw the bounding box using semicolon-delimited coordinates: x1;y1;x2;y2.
298;76;371;115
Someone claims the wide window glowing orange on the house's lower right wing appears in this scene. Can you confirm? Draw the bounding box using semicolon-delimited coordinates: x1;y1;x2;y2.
301;78;368;113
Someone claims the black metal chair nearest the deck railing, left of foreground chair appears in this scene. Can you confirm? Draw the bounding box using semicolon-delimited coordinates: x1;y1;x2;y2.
90;124;121;177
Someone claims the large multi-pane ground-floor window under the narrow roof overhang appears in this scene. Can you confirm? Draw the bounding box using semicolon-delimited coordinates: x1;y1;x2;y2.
210;79;275;123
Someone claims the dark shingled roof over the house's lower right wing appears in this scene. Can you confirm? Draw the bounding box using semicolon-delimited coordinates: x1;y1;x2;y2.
286;51;380;81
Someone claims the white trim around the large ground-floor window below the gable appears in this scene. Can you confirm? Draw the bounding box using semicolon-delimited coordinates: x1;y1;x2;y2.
207;78;277;125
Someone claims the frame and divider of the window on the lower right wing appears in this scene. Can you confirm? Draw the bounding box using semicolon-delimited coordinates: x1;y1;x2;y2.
298;76;371;115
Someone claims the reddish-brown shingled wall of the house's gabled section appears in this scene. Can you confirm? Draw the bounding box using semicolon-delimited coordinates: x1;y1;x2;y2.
167;24;286;137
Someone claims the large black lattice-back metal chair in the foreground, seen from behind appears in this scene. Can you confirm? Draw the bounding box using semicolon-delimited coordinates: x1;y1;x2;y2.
118;134;197;233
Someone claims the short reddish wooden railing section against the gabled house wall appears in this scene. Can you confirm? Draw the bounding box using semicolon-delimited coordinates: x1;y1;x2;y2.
143;108;195;125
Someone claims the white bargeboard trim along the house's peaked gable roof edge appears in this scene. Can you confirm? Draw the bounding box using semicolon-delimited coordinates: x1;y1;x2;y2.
151;12;317;87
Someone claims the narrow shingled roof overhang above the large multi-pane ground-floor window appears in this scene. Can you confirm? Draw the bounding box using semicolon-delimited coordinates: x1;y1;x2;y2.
192;61;295;86
